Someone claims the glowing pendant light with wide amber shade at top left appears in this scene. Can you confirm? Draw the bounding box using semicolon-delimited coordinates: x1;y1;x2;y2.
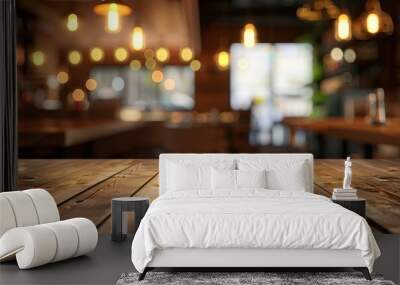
94;0;132;33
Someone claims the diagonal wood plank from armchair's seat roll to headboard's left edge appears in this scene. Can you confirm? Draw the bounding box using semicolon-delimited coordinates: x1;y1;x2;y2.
59;160;158;225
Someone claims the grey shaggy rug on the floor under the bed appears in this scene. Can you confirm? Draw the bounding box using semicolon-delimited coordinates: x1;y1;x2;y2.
117;272;395;285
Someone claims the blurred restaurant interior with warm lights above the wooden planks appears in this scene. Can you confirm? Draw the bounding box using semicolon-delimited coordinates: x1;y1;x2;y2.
17;0;400;158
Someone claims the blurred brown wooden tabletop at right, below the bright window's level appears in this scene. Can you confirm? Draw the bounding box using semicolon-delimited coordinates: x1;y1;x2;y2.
283;118;400;145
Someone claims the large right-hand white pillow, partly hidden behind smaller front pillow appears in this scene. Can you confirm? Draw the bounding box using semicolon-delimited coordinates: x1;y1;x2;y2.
238;159;311;191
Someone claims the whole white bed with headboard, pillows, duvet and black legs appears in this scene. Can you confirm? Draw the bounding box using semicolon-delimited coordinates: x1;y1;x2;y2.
132;154;380;278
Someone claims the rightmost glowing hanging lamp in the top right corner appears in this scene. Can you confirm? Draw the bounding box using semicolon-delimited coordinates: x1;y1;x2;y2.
354;0;393;39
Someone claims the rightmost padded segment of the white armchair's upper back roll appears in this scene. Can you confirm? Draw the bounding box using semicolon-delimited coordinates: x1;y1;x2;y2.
22;188;60;224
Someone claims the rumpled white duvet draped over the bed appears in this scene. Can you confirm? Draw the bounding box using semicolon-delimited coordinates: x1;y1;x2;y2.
132;189;380;272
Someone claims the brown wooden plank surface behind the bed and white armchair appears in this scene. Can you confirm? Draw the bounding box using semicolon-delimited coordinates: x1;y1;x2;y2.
18;159;400;234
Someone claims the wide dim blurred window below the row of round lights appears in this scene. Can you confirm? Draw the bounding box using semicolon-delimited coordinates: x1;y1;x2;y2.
91;66;195;110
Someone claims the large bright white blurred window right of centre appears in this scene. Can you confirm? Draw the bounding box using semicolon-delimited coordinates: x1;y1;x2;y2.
230;43;313;116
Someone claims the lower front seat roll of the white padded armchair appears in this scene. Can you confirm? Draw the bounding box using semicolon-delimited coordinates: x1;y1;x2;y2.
0;218;98;269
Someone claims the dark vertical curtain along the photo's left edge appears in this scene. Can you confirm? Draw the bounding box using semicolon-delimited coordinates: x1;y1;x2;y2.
0;0;18;192
